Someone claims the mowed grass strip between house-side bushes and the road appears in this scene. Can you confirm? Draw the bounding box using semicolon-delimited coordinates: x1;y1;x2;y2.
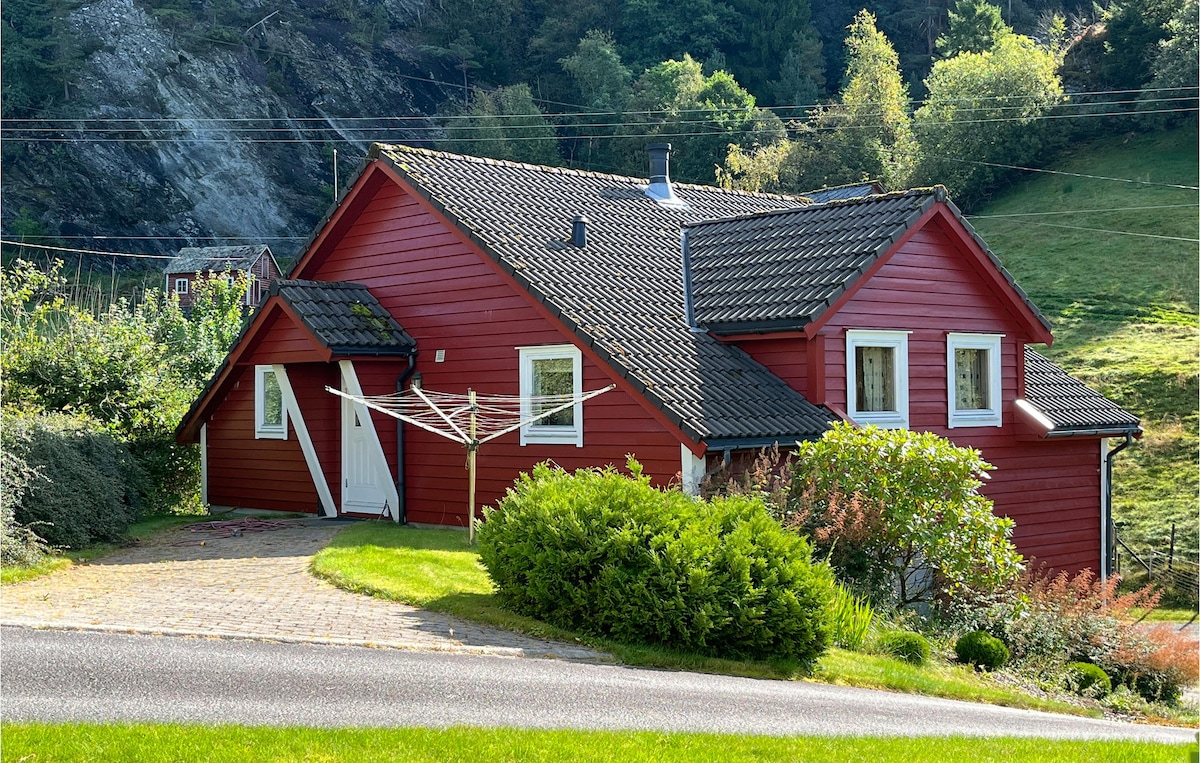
312;522;1100;716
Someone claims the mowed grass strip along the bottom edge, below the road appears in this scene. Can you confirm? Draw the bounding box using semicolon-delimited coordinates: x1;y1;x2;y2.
2;723;1194;763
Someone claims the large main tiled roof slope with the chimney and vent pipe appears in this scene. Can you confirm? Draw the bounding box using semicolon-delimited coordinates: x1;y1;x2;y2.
372;145;835;446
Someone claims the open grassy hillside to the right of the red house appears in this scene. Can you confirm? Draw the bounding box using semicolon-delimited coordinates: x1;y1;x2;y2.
971;127;1200;558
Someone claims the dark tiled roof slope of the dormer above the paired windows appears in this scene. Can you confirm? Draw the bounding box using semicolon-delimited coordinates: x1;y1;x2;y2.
686;186;946;334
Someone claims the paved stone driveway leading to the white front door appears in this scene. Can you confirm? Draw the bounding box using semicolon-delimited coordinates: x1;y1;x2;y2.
0;519;606;660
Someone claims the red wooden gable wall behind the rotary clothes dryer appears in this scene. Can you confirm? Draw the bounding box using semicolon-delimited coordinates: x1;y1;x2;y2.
298;184;680;525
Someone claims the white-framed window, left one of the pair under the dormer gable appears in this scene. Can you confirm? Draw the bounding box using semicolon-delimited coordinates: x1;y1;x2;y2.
846;331;908;428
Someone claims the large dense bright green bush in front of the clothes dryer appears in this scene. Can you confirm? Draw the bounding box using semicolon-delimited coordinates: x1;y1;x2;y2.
479;459;834;667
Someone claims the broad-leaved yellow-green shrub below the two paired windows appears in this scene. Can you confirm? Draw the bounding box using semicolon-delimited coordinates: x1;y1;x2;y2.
788;422;1021;606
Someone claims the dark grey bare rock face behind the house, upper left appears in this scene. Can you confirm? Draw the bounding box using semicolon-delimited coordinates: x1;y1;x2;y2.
4;0;440;256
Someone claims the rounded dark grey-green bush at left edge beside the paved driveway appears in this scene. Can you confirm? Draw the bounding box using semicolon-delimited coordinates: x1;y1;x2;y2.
0;413;143;548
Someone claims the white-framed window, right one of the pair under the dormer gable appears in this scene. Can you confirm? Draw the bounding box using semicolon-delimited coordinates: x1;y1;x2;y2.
946;334;1002;429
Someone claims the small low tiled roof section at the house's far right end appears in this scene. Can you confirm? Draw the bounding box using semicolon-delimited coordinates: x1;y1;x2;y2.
1025;347;1141;437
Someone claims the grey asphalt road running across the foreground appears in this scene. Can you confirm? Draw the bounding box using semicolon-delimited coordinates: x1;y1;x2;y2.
0;627;1195;743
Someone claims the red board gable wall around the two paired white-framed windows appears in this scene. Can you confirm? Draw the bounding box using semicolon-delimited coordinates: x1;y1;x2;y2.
772;214;1100;570
